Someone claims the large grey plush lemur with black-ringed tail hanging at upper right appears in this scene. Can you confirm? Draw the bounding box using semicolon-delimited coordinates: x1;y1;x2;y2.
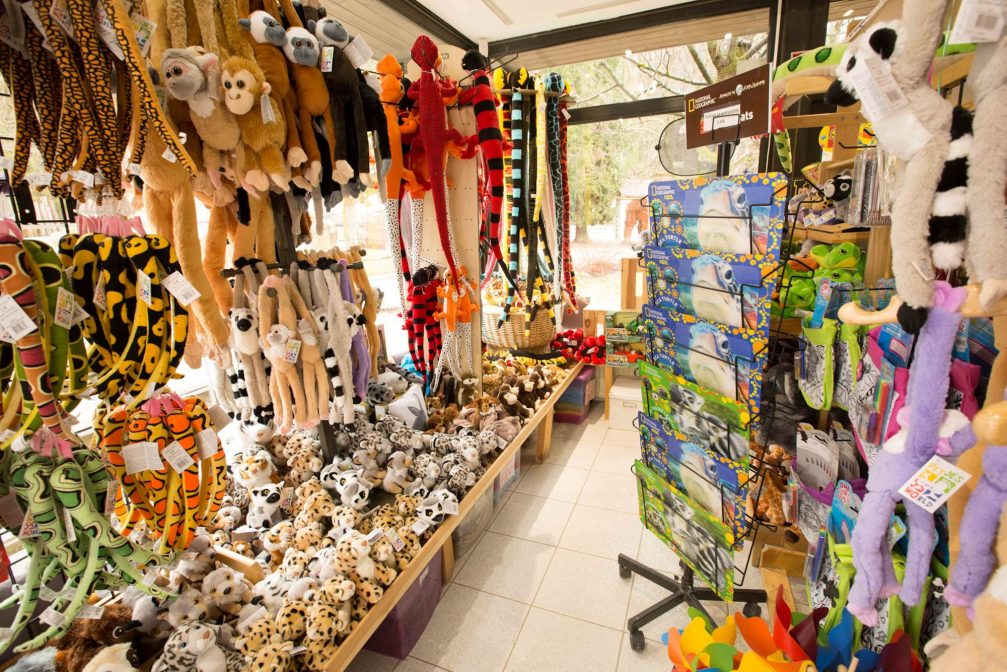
826;9;972;333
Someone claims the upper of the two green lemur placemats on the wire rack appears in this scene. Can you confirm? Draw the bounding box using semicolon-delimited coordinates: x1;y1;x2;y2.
639;362;751;468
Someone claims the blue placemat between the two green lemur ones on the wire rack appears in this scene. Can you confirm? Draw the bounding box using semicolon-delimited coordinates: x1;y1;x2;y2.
638;413;748;541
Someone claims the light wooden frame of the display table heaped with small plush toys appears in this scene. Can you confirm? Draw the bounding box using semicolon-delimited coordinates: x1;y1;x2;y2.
217;363;584;672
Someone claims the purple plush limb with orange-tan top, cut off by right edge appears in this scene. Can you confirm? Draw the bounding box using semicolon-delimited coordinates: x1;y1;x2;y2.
945;394;1007;607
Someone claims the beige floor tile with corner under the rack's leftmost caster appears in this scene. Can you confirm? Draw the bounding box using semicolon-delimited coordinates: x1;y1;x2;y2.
533;548;631;630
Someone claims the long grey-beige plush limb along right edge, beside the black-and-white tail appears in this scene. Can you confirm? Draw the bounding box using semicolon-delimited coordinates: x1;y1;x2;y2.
966;35;1007;308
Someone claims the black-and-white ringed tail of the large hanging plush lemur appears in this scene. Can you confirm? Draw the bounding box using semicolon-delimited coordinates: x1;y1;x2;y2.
926;107;972;271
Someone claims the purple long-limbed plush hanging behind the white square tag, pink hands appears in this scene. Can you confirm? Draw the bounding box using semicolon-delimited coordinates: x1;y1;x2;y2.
847;282;976;627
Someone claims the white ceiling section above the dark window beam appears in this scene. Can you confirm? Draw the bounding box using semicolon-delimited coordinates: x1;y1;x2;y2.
410;0;686;42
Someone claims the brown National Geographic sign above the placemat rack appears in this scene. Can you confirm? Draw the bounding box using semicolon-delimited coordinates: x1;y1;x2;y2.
686;64;769;149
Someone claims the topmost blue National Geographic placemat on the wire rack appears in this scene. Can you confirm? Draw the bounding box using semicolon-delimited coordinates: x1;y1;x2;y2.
649;172;786;261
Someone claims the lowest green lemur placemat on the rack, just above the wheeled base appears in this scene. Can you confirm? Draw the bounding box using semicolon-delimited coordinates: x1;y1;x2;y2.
633;460;734;601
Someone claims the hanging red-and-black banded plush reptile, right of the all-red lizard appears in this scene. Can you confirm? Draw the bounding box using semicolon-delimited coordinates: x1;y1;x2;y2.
458;49;518;290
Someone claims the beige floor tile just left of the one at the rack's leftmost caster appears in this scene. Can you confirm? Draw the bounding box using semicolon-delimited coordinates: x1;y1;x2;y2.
453;532;556;604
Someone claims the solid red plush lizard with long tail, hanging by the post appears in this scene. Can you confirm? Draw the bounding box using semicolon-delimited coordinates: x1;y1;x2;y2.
409;35;470;291
